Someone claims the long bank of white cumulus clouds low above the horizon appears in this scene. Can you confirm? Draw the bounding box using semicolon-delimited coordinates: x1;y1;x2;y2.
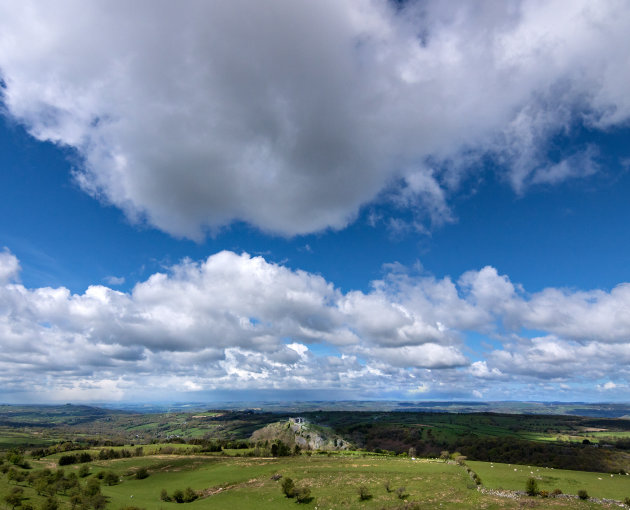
0;250;630;401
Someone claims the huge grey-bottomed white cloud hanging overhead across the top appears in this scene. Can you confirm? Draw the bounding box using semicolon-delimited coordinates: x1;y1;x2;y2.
0;0;630;238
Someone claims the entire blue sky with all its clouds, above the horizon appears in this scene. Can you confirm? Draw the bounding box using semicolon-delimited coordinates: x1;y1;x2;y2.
0;0;630;402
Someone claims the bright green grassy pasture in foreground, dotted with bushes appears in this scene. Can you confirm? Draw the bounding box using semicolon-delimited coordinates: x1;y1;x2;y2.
0;455;630;510
